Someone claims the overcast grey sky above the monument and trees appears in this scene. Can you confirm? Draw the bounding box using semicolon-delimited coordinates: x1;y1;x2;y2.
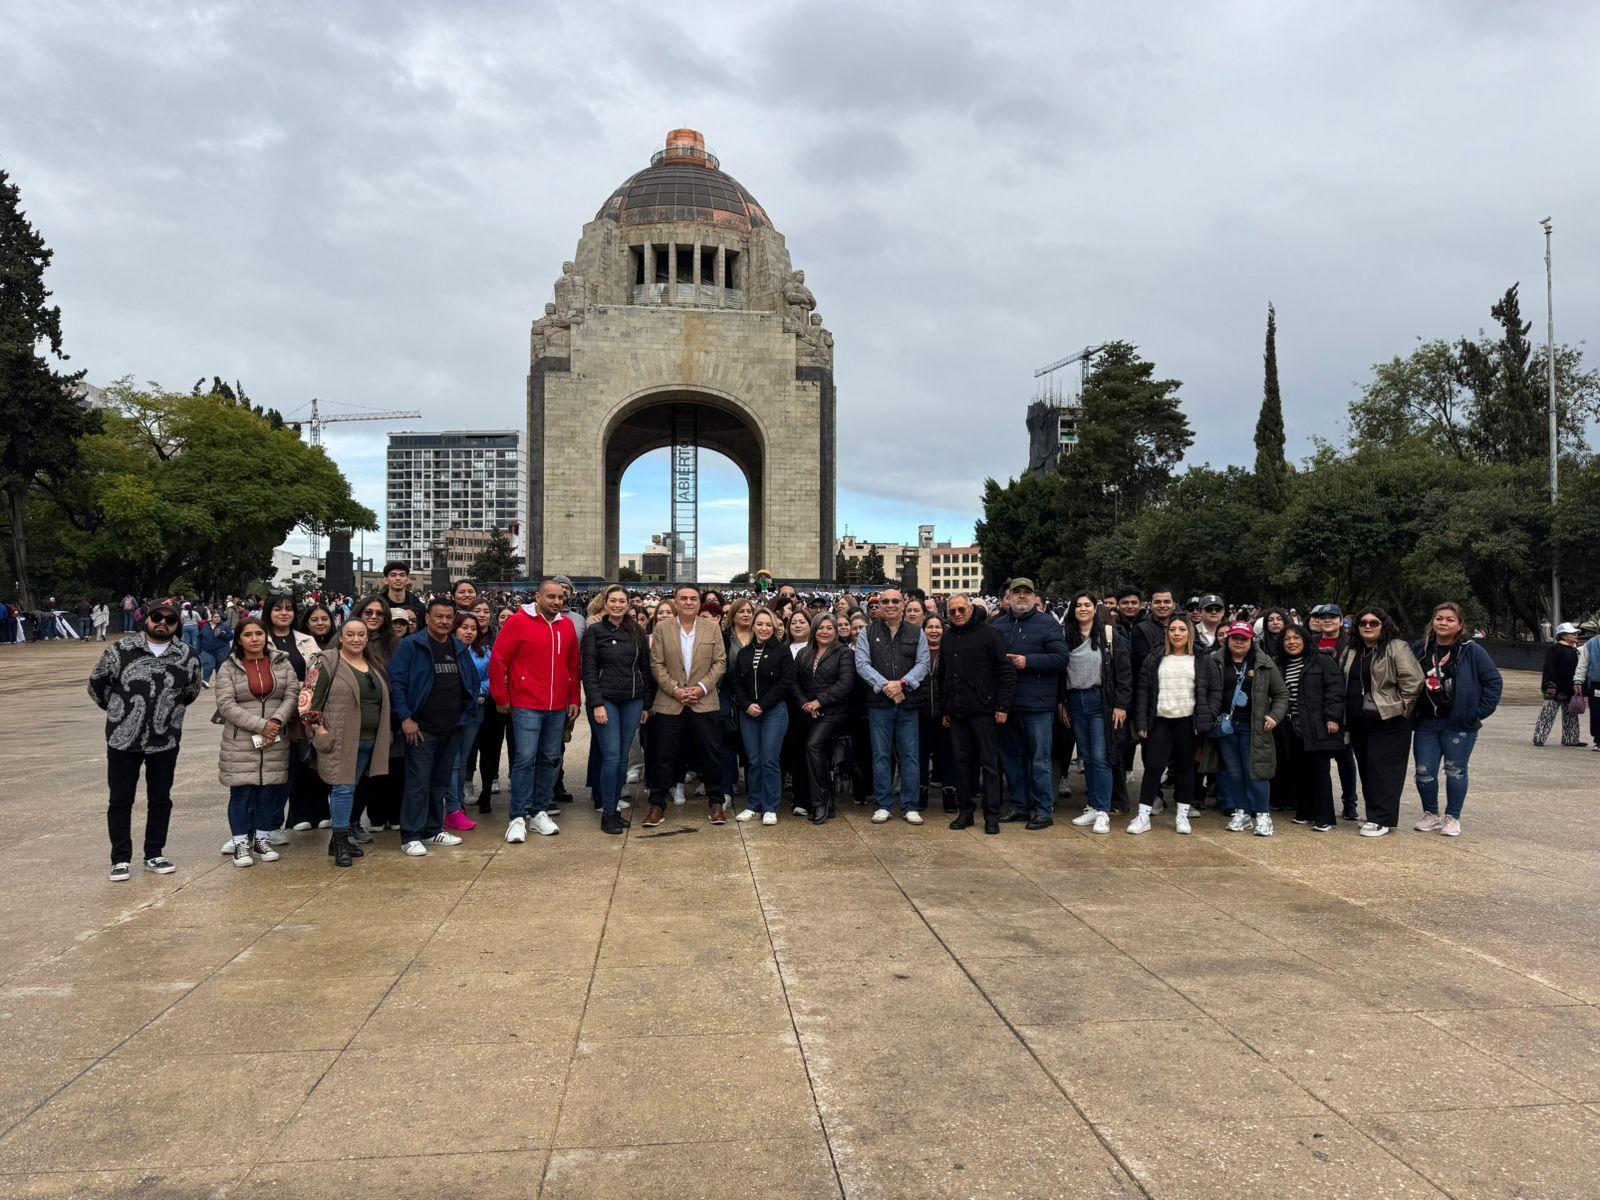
0;0;1600;570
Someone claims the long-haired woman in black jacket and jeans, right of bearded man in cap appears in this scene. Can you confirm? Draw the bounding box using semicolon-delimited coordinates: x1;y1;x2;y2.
1062;592;1133;834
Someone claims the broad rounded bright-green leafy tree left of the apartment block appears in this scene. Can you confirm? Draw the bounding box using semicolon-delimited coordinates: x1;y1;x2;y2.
53;379;376;595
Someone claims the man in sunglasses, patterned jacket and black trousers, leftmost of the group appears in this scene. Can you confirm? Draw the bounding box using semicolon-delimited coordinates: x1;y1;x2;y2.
90;600;200;883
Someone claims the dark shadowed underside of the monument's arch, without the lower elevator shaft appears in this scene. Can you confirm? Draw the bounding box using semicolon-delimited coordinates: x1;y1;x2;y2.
597;386;768;573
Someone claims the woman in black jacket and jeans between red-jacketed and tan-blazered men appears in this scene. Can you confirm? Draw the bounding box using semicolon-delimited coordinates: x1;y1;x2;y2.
579;584;654;835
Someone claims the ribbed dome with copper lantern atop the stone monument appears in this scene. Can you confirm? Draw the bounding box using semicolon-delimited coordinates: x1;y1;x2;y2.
595;130;773;234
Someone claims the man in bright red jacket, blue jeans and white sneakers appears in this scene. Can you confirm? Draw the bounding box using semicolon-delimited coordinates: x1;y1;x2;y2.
490;579;582;843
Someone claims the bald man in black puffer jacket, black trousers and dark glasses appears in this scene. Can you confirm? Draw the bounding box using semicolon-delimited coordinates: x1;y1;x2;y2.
933;595;1017;834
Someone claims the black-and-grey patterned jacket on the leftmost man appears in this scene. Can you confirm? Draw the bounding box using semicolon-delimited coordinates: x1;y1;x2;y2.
90;634;200;754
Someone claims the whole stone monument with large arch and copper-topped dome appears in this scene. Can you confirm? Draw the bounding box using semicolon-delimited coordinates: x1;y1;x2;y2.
528;130;835;579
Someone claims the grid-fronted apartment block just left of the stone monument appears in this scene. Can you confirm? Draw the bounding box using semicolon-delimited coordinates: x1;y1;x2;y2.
384;429;528;573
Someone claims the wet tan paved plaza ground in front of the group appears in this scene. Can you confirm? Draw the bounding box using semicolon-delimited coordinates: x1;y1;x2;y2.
0;643;1600;1200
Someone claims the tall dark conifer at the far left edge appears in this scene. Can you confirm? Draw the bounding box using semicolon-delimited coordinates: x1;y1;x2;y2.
0;171;99;608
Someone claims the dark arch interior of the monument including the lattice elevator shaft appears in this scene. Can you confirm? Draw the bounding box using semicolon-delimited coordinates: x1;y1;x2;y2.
600;389;766;578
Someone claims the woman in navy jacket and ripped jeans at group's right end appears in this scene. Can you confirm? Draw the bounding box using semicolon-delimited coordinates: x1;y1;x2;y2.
1411;600;1502;837
